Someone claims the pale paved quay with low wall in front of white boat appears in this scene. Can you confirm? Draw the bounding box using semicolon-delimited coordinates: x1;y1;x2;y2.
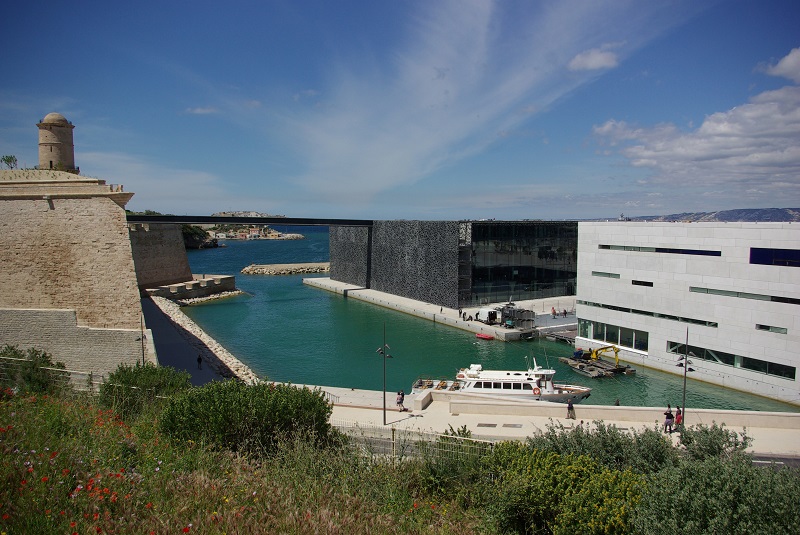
316;385;800;459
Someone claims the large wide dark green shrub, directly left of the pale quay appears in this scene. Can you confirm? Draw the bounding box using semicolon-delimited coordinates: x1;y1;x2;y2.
160;381;332;454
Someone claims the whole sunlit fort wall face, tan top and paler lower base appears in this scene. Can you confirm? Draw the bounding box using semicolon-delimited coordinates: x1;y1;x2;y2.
0;188;143;374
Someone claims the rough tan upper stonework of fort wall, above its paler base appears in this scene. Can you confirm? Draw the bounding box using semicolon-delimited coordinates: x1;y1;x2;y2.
0;197;141;330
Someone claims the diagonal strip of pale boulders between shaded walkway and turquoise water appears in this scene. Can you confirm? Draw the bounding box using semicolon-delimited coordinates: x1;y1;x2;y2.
150;296;259;384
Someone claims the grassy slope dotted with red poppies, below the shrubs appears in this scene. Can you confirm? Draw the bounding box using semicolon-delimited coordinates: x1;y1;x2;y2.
0;391;481;534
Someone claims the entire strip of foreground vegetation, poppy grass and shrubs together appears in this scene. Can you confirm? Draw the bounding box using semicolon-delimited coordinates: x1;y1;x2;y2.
0;348;800;534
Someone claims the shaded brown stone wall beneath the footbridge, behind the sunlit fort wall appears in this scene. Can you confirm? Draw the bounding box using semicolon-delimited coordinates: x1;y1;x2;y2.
129;224;192;289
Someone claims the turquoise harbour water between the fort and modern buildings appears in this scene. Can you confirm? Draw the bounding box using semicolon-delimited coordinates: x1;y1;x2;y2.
183;229;798;411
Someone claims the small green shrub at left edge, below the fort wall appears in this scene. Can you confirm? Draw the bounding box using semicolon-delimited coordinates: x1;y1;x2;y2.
0;345;69;394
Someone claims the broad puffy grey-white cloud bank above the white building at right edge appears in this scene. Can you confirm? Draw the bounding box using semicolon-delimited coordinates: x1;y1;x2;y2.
594;49;800;205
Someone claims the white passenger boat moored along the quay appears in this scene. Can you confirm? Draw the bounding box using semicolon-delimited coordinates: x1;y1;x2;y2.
411;359;592;403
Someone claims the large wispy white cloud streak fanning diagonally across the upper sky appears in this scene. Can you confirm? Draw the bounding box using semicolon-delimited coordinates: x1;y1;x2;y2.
270;0;674;202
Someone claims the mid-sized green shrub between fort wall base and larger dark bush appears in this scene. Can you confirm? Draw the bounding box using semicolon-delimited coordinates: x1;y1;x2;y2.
100;363;192;419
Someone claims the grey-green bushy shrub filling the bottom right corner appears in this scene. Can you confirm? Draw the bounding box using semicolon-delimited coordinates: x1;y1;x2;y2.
633;456;800;535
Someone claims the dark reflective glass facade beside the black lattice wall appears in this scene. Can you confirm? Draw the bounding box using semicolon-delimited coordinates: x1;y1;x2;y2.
459;221;578;306
